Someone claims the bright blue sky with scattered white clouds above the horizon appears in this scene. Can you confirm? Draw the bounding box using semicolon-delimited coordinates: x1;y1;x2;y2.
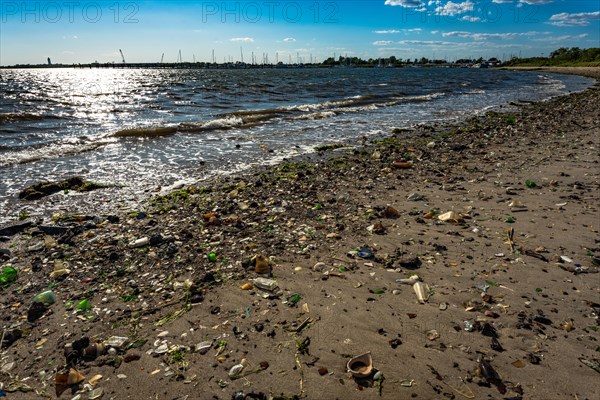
0;0;600;65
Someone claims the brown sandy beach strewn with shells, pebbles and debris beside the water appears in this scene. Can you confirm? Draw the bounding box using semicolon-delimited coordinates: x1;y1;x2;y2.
0;68;600;400
